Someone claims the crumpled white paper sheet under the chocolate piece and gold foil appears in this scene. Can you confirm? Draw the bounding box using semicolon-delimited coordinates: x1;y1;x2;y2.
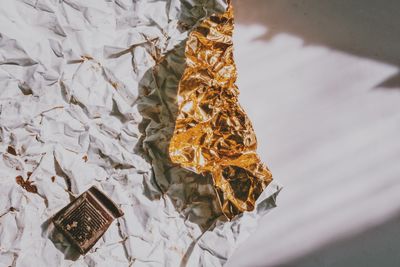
0;0;280;267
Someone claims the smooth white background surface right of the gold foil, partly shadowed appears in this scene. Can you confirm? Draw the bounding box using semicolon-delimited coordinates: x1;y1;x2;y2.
227;0;400;267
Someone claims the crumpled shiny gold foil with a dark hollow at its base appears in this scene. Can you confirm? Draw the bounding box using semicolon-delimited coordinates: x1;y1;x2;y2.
169;3;272;219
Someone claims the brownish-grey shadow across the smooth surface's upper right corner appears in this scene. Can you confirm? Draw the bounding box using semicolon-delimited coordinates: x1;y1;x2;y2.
233;0;400;89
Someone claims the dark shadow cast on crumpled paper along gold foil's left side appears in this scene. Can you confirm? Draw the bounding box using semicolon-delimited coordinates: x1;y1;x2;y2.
131;1;233;231
